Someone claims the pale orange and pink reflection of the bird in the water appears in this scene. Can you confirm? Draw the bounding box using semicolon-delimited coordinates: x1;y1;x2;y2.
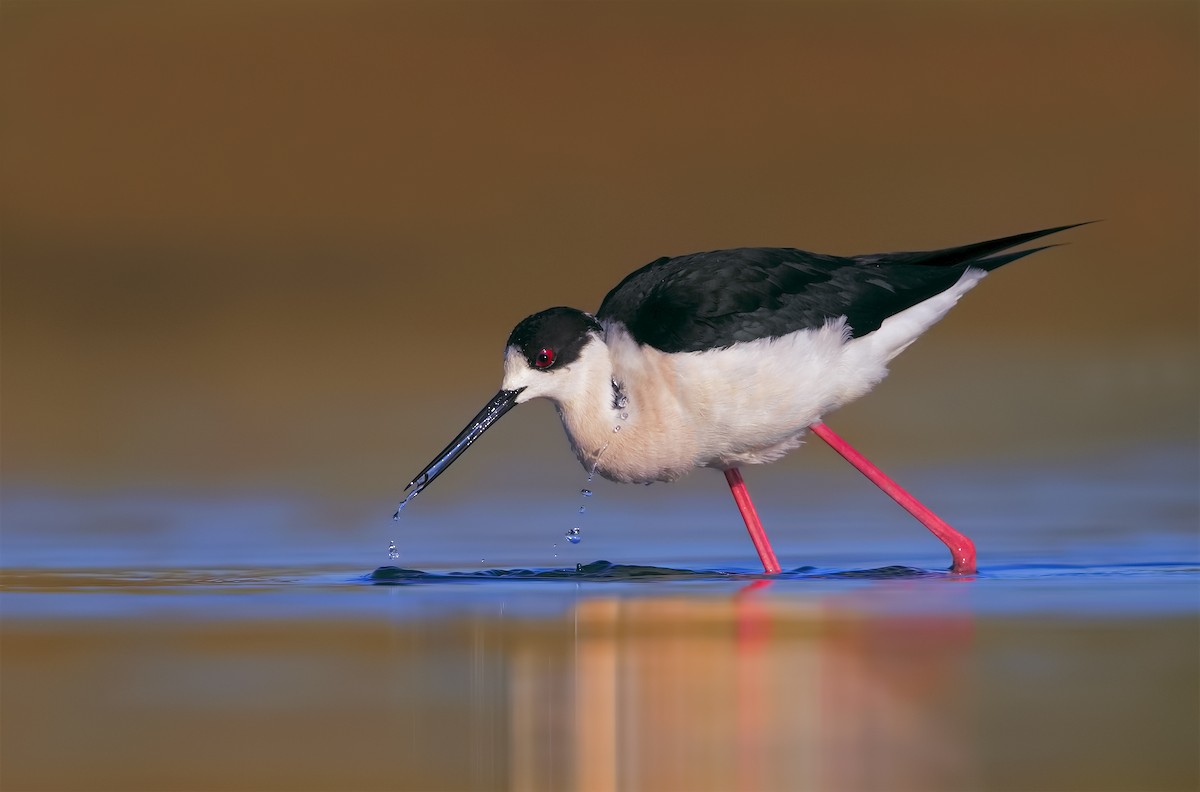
508;581;973;790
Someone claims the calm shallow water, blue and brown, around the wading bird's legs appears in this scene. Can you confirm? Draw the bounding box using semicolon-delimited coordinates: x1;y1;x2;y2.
0;446;1200;790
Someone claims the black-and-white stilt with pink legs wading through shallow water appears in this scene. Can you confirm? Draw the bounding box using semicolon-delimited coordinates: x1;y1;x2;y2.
395;223;1081;572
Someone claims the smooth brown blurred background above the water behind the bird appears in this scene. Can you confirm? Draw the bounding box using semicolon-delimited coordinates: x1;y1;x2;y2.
0;0;1200;497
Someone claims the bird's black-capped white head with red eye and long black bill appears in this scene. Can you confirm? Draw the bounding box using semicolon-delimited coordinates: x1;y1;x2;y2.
394;307;602;517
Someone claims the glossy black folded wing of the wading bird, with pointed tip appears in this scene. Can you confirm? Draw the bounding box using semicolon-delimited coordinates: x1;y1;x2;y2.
596;223;1079;352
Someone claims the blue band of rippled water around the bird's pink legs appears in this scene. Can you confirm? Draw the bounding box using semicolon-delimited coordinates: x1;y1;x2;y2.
0;446;1200;618
